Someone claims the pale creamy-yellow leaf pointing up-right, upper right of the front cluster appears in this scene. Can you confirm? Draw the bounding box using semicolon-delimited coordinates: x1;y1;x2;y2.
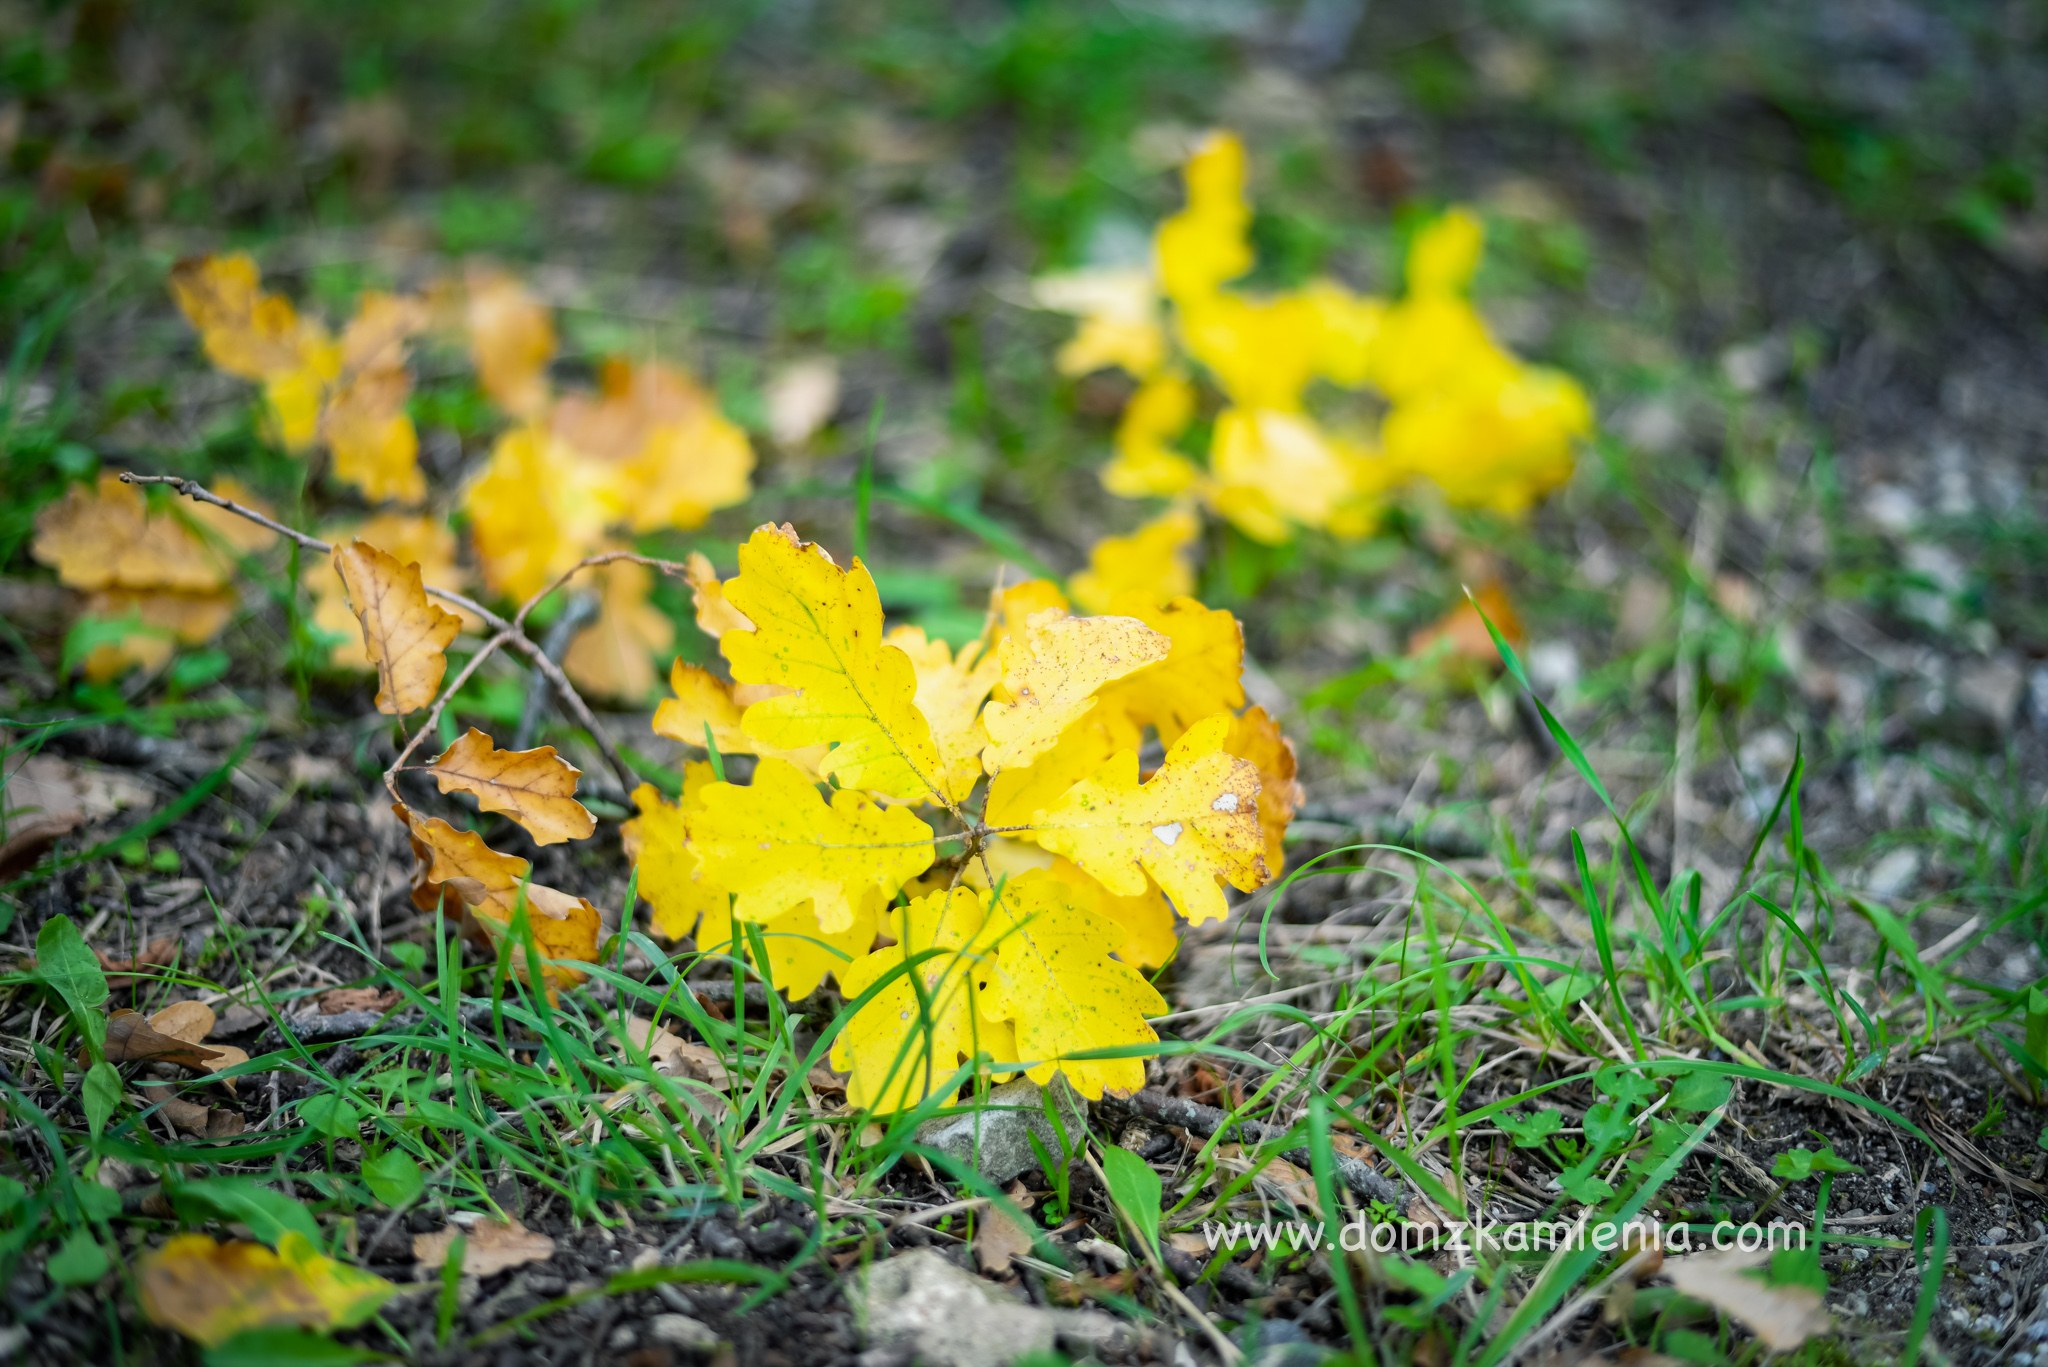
981;613;1167;773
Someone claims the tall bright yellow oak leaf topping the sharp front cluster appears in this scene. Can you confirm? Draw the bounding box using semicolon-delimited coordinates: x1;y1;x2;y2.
719;527;946;803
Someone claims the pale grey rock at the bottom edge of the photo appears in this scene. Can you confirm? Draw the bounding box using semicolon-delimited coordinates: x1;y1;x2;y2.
854;1248;1122;1367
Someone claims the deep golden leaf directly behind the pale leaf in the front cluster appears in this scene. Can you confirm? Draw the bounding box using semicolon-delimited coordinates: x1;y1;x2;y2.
1100;596;1245;750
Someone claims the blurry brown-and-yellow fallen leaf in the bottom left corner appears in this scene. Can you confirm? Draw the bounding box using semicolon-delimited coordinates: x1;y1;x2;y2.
135;1230;397;1349
